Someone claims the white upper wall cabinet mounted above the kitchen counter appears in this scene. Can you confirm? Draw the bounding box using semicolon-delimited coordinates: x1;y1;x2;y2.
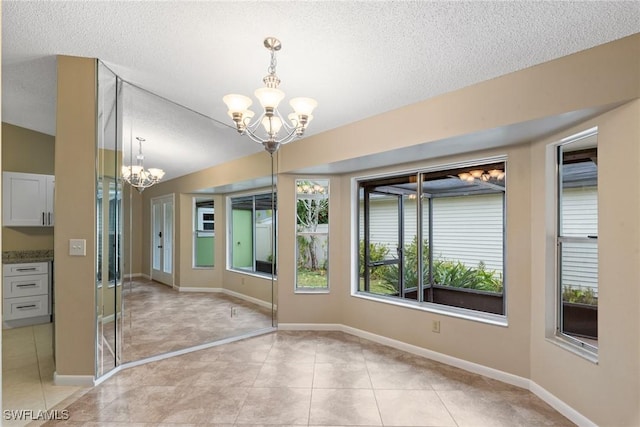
2;172;55;227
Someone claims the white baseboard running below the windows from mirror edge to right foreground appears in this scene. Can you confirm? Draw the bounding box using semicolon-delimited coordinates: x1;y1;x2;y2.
278;323;597;427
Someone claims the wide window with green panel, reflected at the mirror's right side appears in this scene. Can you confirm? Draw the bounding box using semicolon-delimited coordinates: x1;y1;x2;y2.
229;193;276;275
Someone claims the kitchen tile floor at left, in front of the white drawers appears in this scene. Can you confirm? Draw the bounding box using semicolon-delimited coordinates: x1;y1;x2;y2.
1;323;87;427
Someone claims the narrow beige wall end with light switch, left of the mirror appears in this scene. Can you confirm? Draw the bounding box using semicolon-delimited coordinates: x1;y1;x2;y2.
54;56;97;376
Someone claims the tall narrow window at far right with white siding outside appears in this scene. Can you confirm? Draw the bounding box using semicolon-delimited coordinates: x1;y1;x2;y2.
556;129;598;353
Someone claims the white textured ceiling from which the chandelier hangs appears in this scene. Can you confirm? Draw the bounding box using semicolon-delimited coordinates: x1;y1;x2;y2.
2;1;640;182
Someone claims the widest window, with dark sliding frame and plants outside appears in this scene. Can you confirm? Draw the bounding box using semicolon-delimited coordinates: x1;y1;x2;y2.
358;161;505;315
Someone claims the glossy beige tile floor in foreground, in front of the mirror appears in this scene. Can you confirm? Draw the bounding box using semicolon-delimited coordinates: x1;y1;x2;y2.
35;331;573;427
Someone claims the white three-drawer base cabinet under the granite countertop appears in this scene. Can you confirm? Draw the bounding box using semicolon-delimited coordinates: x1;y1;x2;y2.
2;262;51;327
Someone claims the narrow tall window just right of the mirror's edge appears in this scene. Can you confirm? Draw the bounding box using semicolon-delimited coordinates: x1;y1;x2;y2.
296;179;329;291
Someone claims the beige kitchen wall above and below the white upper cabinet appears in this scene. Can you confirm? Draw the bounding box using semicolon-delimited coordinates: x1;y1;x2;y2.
2;123;55;251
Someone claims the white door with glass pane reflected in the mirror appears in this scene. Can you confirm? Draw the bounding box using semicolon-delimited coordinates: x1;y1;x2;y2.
151;195;173;286
